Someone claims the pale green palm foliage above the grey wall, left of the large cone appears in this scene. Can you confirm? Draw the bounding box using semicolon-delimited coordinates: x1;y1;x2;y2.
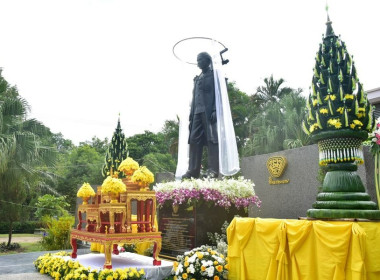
242;76;309;156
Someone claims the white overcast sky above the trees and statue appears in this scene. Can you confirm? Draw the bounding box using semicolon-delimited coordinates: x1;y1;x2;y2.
0;0;380;144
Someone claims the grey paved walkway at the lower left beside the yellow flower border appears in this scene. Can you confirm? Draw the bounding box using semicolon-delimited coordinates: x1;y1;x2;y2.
0;249;90;280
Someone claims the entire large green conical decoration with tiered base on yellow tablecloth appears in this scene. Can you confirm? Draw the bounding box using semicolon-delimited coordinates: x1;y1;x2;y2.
303;13;380;219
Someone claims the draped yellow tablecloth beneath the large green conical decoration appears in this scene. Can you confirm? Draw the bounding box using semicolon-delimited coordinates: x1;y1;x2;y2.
227;218;380;280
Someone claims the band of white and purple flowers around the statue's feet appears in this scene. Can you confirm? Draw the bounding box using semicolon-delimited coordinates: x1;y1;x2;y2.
153;177;261;209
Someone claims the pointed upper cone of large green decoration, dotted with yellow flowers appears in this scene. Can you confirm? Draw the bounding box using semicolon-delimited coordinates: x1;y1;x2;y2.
304;17;374;135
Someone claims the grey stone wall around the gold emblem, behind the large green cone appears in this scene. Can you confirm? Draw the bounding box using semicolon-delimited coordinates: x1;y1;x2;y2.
241;144;377;219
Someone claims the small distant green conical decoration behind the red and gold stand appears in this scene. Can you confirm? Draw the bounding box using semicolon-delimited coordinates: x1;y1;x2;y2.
102;118;128;178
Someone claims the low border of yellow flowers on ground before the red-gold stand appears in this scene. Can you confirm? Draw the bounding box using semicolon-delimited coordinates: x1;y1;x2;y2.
34;251;146;280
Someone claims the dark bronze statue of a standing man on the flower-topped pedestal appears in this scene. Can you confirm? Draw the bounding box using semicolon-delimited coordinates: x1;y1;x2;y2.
182;52;219;179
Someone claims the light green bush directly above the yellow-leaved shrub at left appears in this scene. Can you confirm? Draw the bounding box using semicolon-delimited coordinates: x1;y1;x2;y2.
34;194;70;220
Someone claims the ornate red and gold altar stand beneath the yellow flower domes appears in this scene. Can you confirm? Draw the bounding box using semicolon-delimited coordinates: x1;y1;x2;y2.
70;187;161;269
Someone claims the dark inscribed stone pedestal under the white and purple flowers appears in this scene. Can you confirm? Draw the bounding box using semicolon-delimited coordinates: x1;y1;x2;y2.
158;203;247;257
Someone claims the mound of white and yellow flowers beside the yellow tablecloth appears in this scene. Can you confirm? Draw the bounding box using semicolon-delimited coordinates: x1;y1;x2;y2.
172;245;228;280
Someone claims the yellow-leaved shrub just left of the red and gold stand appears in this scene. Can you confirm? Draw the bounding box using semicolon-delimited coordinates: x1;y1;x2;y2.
41;215;75;250
